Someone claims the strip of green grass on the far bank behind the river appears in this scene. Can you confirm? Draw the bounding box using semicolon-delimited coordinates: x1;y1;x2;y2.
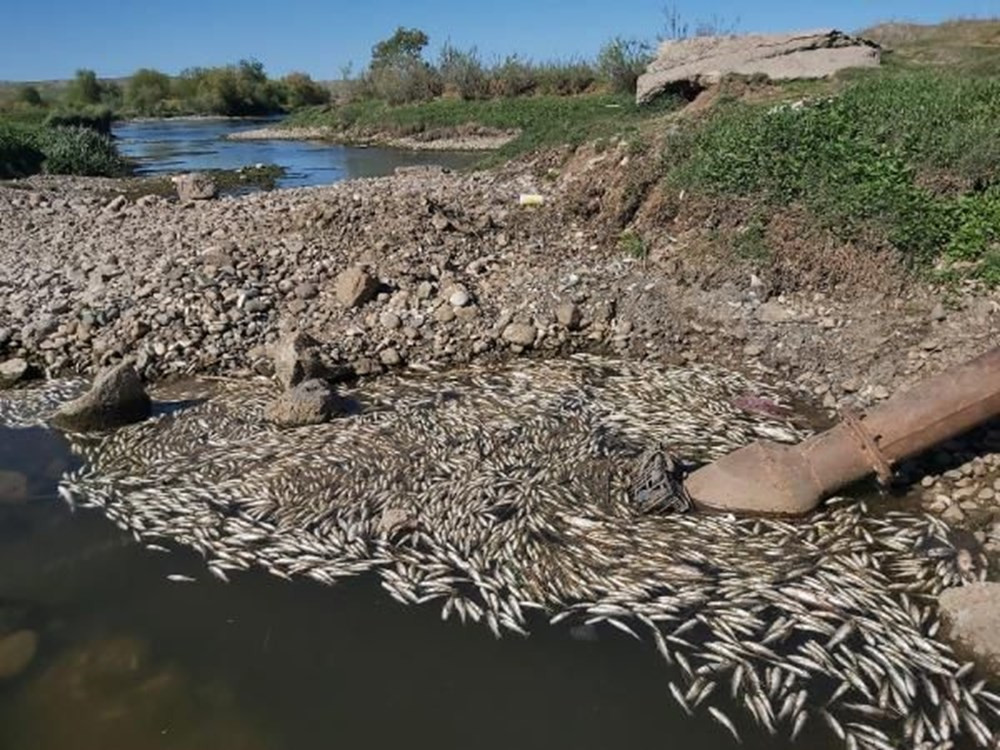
284;94;678;159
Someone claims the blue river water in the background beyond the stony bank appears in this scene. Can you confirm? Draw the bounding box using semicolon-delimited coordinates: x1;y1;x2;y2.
114;119;481;187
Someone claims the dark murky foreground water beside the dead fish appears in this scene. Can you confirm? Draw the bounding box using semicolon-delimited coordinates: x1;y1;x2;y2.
0;427;837;750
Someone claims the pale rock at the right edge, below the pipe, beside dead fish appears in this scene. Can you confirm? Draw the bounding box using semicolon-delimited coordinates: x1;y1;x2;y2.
938;583;1000;674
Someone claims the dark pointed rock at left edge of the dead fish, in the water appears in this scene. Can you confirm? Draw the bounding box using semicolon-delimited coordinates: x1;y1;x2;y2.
52;362;152;432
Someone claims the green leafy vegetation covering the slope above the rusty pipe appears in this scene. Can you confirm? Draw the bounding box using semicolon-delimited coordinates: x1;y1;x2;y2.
670;69;1000;279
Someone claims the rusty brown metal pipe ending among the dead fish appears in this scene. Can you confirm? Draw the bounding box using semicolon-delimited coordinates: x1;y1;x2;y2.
685;348;1000;515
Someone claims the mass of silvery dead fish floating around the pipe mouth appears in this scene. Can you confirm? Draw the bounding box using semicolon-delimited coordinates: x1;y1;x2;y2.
0;357;1000;750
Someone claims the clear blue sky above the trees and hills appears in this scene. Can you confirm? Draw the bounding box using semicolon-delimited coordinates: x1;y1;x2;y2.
0;0;1000;80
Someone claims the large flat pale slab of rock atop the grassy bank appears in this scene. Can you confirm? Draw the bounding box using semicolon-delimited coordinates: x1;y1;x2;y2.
635;29;881;104
